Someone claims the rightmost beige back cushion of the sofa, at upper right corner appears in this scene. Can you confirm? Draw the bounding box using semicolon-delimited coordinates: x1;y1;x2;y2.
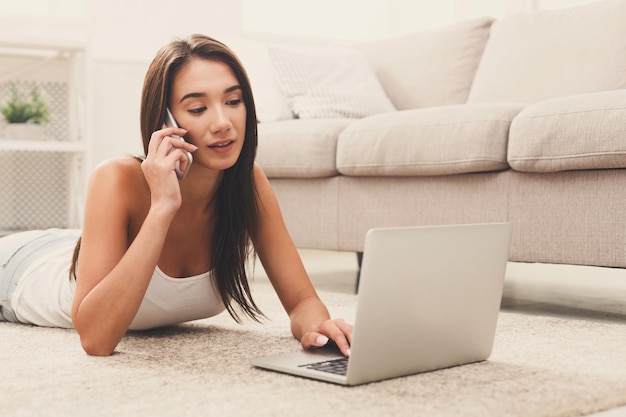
468;0;626;103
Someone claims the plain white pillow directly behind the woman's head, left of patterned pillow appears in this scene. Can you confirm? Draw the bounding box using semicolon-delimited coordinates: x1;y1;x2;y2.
220;38;293;123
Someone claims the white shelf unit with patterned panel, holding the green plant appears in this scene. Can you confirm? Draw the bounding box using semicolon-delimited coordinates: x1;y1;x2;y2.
0;37;92;235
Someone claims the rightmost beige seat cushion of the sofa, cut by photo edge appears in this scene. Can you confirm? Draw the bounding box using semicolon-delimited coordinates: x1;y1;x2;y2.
508;90;626;172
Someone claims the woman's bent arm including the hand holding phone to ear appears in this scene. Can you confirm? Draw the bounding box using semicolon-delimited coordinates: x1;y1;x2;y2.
72;129;193;355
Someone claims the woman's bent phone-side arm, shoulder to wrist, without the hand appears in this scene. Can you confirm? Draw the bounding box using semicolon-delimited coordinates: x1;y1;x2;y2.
72;161;168;355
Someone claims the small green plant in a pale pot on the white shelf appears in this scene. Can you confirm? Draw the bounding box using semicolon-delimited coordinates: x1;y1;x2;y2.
0;84;50;140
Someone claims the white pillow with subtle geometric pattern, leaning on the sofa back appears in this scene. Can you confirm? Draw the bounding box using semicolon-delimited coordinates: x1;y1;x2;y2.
268;46;395;119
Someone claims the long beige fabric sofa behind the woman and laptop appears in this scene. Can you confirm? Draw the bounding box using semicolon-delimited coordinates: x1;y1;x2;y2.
227;1;626;314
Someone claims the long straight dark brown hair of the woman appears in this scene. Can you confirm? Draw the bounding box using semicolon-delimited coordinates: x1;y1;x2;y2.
70;34;263;322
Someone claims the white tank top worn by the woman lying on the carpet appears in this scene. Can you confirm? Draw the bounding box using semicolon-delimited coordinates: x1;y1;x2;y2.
11;242;225;330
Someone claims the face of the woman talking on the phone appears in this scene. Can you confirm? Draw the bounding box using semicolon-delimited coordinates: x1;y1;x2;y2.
169;58;246;171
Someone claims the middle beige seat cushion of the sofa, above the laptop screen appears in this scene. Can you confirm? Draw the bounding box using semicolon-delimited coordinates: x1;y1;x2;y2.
337;103;524;176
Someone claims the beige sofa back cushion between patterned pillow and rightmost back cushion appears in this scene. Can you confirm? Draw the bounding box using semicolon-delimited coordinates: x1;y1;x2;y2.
351;18;493;110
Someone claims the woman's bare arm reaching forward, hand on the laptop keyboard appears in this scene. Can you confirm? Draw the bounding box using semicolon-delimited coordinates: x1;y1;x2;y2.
254;162;352;356
